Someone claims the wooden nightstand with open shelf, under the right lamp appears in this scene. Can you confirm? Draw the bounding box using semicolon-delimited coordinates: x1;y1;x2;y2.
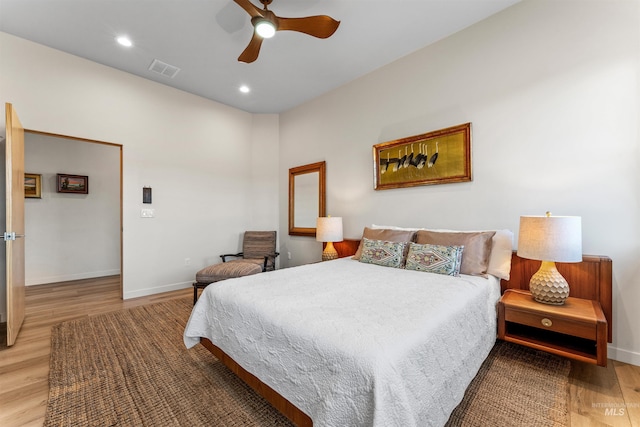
498;289;607;366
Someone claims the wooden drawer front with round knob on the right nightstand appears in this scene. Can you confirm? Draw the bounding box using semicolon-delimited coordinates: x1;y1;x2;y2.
505;308;597;340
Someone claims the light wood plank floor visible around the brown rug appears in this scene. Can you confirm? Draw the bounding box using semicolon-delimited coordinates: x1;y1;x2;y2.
0;276;640;427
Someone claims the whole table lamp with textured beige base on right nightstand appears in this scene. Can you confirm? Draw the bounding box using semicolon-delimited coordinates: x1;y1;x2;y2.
518;212;582;305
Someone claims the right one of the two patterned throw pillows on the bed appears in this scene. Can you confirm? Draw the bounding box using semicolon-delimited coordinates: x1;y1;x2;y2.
405;243;464;276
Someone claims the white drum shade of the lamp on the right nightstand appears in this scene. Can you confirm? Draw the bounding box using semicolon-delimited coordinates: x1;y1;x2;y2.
518;216;582;262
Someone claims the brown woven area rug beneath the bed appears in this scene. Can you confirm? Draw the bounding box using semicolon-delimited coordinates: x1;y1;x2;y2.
44;298;570;427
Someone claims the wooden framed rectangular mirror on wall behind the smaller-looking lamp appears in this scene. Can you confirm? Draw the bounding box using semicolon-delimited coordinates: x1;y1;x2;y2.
289;162;326;237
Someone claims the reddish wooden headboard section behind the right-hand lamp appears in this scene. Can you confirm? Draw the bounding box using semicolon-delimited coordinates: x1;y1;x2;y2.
500;251;613;342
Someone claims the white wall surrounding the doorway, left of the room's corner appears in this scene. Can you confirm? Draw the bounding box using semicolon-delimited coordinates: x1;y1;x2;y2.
0;33;279;314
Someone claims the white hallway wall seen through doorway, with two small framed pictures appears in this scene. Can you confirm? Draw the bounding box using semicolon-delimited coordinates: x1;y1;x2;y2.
25;133;120;285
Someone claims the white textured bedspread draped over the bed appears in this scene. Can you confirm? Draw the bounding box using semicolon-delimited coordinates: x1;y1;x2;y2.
184;258;500;427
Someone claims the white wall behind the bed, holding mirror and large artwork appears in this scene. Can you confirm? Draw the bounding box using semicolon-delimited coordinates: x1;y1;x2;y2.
280;0;640;365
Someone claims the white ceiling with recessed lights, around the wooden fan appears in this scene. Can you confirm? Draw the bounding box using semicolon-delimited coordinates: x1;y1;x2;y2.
0;0;519;113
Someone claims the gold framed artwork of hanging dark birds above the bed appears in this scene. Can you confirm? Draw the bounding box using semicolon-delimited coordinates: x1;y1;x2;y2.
373;123;471;190
